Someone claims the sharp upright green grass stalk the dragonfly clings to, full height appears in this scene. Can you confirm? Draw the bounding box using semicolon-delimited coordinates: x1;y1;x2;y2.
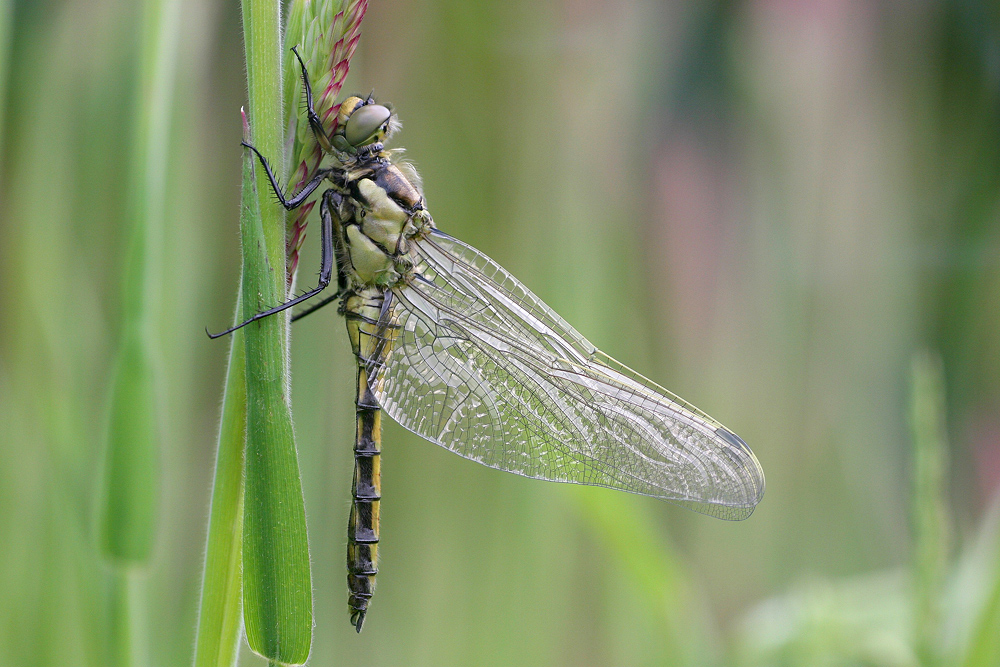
241;0;313;665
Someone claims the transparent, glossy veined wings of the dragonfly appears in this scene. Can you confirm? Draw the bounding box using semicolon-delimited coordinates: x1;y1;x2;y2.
369;232;764;519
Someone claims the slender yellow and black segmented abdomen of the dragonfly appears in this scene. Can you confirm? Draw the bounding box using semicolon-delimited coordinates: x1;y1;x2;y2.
344;287;397;632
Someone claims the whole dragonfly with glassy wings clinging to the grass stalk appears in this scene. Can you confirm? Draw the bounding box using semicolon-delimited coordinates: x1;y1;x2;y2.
210;49;764;632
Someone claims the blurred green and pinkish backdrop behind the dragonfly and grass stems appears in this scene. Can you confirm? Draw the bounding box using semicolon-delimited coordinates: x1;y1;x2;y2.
0;0;1000;667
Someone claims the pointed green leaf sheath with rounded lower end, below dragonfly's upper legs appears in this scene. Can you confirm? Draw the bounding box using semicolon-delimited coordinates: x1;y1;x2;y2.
241;141;312;664
